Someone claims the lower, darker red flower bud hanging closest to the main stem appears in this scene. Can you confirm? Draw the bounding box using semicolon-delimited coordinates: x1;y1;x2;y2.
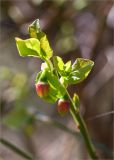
58;99;70;116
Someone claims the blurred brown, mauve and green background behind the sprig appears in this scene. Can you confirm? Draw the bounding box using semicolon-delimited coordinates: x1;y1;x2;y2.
0;0;114;160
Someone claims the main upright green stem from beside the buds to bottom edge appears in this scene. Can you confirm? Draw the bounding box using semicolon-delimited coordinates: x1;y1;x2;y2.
66;89;98;159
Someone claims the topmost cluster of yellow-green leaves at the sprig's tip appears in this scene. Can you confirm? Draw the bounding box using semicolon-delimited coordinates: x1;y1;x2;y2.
15;19;53;60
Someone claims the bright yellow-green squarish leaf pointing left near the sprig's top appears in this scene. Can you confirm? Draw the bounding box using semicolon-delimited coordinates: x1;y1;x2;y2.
15;38;43;58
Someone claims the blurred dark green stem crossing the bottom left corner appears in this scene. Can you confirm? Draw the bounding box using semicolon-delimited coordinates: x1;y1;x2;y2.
0;138;33;160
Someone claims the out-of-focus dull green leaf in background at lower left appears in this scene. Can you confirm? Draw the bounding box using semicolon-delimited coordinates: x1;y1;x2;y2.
3;106;30;129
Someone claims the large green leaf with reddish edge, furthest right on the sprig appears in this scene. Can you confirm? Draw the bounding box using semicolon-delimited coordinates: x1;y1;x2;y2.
67;58;94;84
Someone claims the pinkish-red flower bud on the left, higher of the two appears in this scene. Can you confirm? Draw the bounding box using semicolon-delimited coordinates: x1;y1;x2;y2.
35;82;50;98
